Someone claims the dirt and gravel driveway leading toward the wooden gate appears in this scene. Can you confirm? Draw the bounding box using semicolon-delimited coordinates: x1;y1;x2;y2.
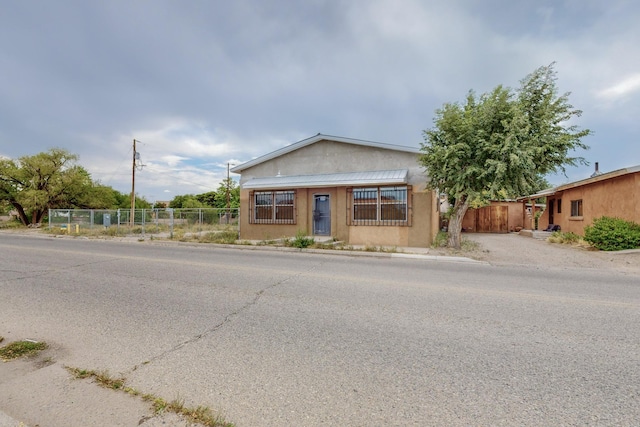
463;233;640;273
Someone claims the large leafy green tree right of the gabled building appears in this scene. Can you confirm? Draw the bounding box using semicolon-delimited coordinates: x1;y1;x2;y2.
420;64;591;248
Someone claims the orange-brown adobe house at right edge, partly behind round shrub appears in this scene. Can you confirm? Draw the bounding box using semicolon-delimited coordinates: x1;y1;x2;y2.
519;163;640;235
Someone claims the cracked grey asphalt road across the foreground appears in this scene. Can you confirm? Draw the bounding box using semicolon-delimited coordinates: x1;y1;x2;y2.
0;234;640;427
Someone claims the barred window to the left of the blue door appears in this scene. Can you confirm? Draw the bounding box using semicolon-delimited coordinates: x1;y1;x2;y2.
251;191;295;224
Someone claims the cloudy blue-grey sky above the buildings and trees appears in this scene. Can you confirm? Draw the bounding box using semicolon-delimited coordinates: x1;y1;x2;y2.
0;0;640;201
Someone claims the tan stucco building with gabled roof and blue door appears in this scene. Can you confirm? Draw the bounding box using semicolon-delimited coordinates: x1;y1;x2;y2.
231;134;439;247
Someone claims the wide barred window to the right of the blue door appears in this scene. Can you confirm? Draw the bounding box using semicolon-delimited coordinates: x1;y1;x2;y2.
352;186;409;225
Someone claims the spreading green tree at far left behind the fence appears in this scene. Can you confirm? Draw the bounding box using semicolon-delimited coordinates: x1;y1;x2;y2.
0;148;114;225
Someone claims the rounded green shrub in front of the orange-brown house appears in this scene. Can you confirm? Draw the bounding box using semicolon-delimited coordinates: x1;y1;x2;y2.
584;216;640;251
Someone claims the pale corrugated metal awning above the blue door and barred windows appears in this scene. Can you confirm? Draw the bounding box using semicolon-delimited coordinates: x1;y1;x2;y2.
242;169;409;190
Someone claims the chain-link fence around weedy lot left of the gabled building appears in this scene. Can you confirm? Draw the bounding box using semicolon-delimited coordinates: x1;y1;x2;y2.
49;208;239;238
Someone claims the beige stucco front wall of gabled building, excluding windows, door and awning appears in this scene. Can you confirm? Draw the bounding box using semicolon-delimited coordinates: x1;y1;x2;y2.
240;141;438;247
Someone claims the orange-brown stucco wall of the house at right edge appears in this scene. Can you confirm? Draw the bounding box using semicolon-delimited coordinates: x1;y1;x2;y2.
539;172;640;235
